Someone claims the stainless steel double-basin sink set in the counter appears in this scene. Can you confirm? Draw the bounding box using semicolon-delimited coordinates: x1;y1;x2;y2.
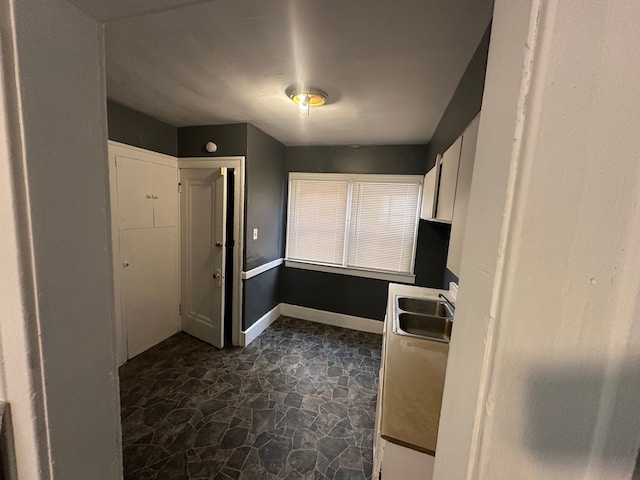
393;297;453;343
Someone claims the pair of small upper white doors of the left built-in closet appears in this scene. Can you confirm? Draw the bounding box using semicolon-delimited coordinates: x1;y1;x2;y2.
116;155;178;229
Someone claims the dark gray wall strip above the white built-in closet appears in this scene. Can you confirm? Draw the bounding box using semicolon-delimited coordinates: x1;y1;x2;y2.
107;100;178;157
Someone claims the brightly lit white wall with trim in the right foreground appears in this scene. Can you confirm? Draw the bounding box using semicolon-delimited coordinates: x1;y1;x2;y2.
434;0;640;480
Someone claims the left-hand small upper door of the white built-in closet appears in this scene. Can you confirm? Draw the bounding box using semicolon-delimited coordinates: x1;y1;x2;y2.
116;155;153;229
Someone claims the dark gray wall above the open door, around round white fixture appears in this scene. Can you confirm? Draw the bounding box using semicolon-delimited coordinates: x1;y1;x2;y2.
178;123;247;157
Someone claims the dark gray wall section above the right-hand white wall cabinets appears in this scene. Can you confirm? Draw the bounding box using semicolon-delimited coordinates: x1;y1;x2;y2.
427;24;491;170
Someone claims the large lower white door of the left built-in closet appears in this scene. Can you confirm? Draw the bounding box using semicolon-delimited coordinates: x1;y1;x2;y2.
120;227;179;358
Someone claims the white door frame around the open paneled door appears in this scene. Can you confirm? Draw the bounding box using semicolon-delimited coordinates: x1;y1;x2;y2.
178;156;245;346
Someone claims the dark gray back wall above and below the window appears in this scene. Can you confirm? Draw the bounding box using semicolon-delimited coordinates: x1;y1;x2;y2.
280;145;428;320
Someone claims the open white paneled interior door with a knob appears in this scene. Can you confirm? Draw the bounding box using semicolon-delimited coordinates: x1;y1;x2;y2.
180;168;227;348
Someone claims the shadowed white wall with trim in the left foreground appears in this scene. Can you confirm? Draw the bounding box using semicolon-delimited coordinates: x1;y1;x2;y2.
0;0;122;480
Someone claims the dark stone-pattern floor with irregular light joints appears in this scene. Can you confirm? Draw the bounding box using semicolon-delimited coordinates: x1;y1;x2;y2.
120;317;382;480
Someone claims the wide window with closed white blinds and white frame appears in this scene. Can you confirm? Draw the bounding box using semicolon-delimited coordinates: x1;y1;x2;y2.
286;173;423;282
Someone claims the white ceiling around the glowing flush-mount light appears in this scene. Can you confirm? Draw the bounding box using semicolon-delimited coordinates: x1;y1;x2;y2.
71;0;492;145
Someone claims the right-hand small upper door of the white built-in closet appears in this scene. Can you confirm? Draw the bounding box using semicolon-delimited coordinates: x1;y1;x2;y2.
149;164;178;227
